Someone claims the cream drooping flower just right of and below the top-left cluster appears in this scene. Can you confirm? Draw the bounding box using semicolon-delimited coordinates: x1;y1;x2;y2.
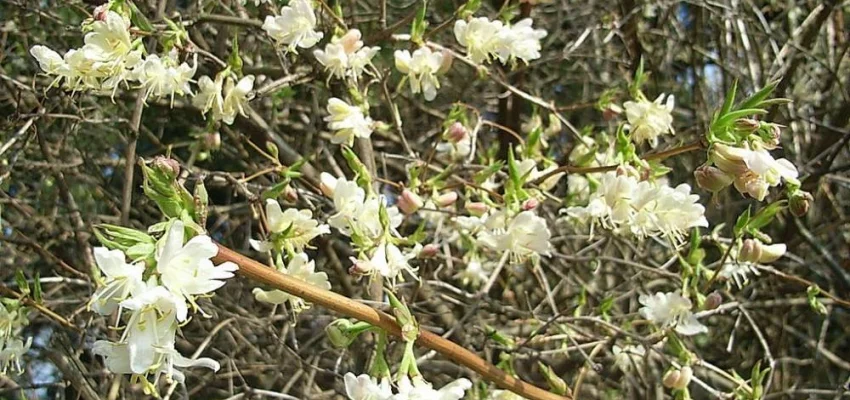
192;74;254;125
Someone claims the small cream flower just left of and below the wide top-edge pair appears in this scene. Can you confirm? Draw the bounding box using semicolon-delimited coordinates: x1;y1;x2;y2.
395;47;443;101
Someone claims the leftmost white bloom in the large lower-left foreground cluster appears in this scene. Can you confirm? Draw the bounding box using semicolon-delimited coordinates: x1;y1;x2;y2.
89;247;145;315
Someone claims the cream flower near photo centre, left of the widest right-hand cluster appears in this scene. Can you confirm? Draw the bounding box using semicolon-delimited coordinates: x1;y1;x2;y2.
478;211;552;260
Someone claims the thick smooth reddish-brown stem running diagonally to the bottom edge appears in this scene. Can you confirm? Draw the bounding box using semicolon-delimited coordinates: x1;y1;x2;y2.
214;245;571;400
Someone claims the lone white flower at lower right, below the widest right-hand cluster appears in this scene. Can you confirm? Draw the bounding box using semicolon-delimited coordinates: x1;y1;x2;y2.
638;292;708;336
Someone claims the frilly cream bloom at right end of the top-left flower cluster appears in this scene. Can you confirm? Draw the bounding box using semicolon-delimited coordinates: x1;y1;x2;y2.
133;52;198;103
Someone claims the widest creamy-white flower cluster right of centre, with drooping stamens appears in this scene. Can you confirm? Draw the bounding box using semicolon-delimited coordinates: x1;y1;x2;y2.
563;172;708;242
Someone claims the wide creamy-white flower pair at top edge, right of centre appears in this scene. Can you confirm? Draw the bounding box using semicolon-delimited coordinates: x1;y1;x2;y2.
454;17;546;64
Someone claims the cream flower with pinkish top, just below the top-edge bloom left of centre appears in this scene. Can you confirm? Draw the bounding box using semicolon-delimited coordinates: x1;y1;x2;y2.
313;29;381;81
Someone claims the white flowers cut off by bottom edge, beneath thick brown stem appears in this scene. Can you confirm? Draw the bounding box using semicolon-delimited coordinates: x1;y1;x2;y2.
344;372;472;400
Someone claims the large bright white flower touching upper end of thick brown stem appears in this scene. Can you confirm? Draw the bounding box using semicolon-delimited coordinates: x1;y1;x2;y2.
156;220;238;301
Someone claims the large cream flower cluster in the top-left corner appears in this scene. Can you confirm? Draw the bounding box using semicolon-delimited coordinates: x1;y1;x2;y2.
30;10;197;101
